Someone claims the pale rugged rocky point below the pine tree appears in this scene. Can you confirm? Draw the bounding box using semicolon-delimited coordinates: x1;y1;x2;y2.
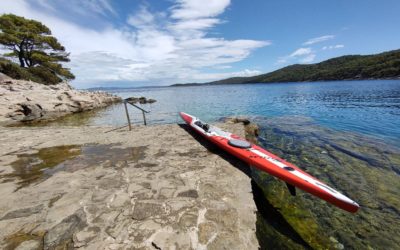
0;73;122;125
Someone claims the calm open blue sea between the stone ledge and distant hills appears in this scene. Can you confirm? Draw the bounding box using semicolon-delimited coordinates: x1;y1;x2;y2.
76;80;400;145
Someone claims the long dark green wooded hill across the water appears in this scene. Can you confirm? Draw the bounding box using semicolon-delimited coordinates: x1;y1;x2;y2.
171;49;400;86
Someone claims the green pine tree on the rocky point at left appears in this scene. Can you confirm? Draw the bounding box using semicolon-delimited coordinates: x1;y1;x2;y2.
0;14;75;83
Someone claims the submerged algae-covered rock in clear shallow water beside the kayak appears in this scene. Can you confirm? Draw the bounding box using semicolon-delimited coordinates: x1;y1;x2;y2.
252;117;400;249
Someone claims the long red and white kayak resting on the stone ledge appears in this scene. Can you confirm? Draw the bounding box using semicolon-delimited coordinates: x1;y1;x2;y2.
179;112;360;213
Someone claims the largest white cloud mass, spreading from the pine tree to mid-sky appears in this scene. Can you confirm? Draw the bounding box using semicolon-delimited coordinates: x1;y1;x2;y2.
0;0;270;86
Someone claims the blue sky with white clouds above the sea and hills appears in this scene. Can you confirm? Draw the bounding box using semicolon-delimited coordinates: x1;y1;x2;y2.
0;0;400;88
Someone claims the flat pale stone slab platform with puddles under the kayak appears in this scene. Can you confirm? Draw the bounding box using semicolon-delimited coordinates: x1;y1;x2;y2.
0;123;258;249
